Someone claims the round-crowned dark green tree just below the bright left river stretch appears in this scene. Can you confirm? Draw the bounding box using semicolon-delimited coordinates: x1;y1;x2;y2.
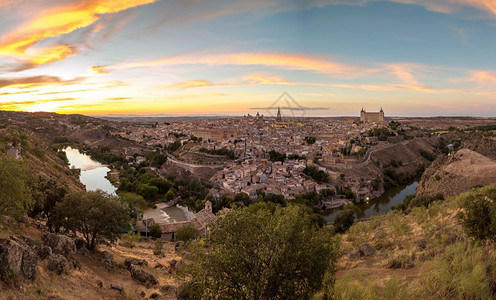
55;191;129;249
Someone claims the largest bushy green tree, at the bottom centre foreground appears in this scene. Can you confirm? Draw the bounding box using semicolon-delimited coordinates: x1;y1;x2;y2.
180;203;337;299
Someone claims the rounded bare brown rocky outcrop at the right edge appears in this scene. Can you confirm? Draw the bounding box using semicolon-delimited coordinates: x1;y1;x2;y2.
415;149;496;197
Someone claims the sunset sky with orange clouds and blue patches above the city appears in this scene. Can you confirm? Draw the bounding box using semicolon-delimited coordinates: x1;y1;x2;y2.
0;0;496;116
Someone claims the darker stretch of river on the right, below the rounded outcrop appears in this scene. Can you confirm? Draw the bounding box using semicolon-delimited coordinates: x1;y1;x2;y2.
325;181;418;223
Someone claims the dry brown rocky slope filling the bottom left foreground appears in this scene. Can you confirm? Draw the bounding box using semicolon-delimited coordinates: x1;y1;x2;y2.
0;219;181;299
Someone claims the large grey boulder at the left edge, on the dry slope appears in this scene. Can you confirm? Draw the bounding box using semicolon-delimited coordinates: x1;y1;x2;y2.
0;237;38;279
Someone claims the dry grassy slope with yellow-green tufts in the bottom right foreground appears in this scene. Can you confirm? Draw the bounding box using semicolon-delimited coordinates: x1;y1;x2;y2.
334;185;496;299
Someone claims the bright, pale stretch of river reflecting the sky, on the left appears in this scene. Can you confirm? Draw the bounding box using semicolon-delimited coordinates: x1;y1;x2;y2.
64;147;117;195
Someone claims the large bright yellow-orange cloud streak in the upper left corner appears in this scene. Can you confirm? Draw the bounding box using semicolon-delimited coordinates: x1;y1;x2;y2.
0;0;155;66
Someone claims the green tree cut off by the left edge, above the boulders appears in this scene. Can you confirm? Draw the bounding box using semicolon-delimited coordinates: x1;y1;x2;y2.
0;153;33;219
